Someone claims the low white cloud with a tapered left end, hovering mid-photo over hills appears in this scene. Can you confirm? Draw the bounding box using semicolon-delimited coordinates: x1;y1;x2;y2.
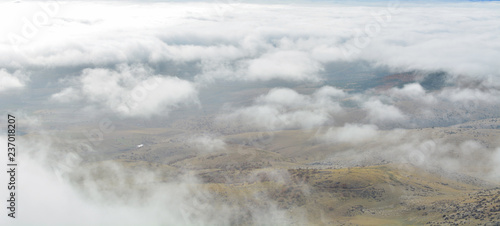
221;86;345;130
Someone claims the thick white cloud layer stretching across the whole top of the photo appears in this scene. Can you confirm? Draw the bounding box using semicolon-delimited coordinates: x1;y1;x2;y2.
0;2;500;84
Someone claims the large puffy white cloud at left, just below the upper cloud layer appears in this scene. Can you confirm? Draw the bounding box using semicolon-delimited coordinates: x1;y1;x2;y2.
52;65;198;117
